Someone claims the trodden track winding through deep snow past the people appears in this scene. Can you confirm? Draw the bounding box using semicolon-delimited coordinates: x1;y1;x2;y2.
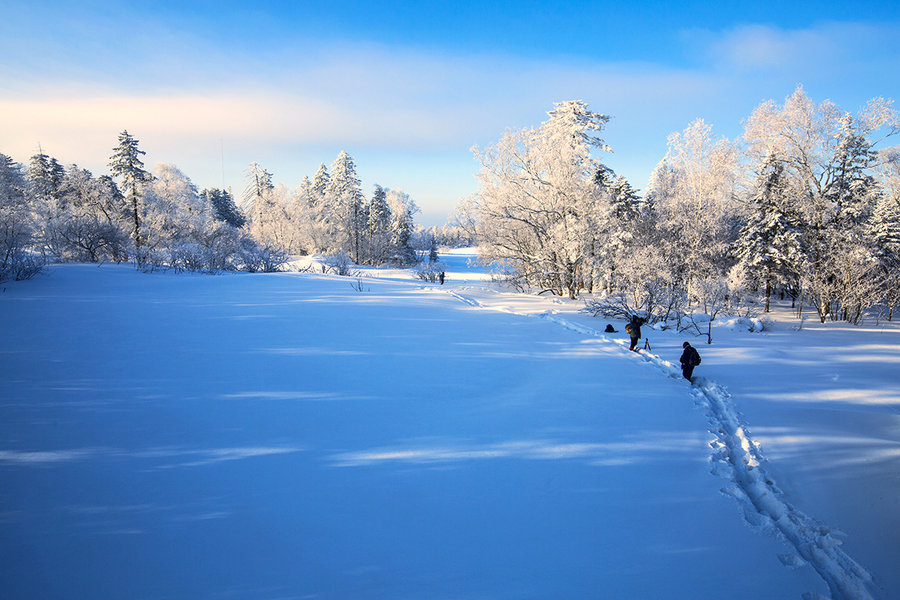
448;290;874;600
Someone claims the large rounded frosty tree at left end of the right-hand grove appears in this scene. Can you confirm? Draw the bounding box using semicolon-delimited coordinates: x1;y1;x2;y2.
474;101;609;298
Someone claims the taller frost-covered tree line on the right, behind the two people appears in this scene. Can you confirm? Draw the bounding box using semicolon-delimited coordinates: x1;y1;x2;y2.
458;87;900;333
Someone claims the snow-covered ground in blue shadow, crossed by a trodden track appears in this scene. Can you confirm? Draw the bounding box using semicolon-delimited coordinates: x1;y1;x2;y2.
0;252;900;600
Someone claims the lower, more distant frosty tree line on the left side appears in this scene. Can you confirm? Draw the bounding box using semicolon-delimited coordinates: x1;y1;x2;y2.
0;131;421;281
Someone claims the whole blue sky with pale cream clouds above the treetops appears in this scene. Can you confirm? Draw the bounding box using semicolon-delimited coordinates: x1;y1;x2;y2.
0;0;900;224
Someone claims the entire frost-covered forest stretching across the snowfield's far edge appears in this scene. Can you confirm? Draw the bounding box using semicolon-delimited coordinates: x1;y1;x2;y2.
0;87;900;327
